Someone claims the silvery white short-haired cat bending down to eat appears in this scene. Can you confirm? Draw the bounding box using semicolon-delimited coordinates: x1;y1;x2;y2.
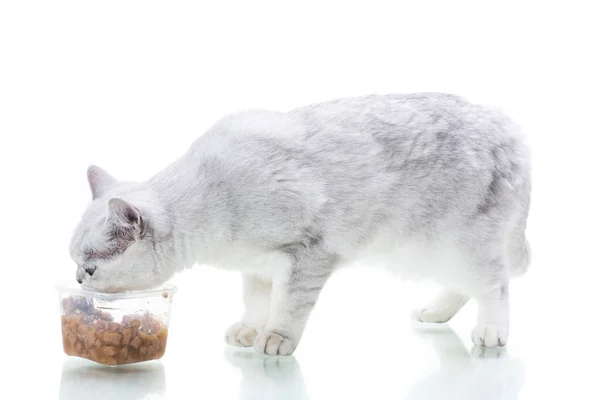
70;93;531;355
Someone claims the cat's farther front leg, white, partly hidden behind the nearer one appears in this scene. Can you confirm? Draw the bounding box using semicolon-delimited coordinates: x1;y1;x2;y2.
225;274;271;347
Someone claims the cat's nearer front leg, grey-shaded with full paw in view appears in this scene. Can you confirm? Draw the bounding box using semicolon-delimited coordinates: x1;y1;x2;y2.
254;247;336;356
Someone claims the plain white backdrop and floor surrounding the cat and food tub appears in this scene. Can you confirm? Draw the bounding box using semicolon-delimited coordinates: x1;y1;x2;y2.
0;0;600;400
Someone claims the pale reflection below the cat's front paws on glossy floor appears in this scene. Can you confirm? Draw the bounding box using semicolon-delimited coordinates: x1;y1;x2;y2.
225;347;309;400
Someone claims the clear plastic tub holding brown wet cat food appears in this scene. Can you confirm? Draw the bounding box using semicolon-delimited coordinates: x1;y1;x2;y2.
57;284;177;365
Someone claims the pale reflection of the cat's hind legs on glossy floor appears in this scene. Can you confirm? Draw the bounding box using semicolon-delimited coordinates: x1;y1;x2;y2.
406;325;524;400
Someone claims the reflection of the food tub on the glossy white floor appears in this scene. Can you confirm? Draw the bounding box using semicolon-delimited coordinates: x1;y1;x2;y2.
59;358;166;400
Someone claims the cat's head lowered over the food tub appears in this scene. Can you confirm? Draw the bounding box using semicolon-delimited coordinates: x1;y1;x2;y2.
70;166;174;292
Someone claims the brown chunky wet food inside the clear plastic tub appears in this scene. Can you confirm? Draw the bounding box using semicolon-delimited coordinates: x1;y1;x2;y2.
61;297;168;365
